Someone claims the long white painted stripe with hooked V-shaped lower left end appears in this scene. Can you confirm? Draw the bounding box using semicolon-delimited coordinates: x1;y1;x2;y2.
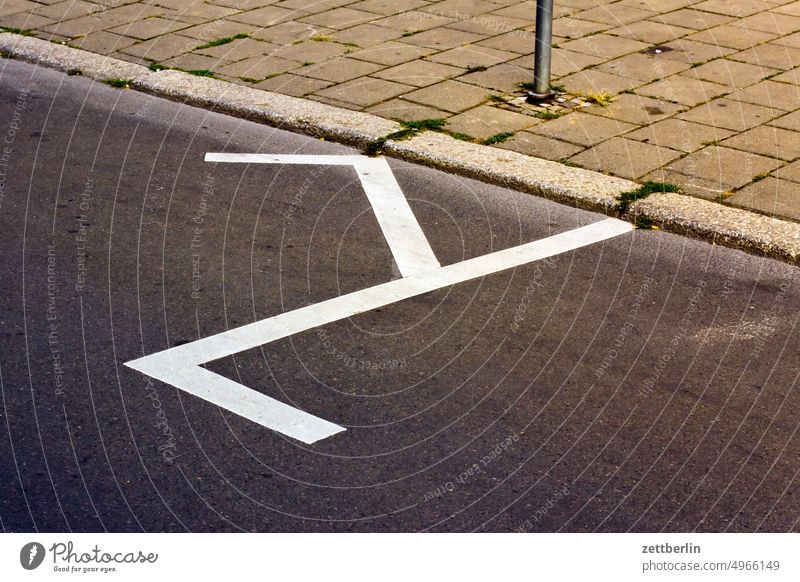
125;218;633;444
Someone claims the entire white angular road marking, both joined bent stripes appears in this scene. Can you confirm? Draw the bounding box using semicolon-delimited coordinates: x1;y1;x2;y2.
125;153;633;444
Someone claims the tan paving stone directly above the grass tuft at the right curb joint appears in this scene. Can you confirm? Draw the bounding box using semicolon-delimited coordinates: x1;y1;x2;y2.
570;137;680;180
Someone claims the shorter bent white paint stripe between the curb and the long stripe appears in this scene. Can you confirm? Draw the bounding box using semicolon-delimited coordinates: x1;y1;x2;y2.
205;152;439;277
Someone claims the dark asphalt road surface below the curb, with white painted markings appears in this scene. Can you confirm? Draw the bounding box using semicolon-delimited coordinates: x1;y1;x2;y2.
0;60;800;532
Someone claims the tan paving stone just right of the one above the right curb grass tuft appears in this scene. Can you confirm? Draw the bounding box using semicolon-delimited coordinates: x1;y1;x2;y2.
666;146;781;189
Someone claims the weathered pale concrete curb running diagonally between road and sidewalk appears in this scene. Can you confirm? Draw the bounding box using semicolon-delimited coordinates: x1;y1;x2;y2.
0;33;800;264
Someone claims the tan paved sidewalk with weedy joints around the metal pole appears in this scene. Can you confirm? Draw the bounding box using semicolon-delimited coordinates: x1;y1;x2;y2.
6;0;800;220
